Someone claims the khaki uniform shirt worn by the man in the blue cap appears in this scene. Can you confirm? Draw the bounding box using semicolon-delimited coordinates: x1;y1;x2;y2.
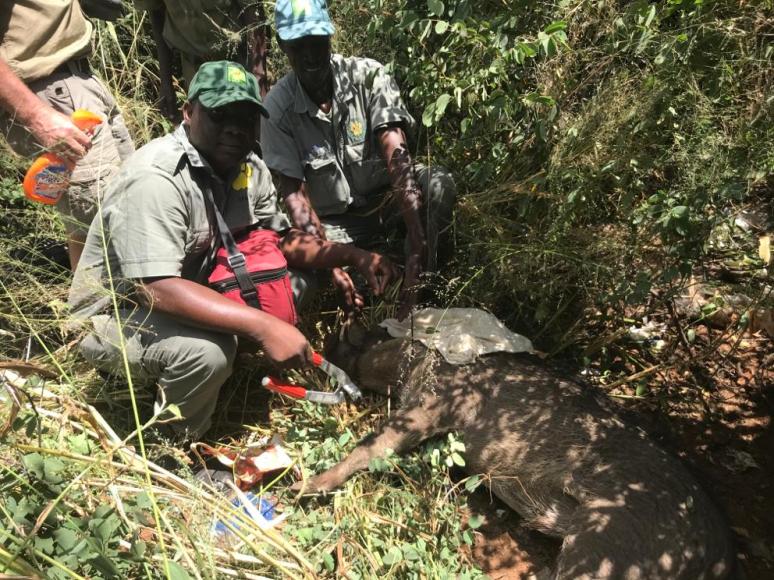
261;54;414;216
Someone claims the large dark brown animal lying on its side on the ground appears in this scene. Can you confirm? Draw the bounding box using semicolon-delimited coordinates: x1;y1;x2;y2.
303;330;735;580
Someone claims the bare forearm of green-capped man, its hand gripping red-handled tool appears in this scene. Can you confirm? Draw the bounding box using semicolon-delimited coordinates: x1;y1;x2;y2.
139;277;311;368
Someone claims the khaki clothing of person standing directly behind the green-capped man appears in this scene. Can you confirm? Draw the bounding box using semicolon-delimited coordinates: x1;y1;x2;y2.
134;0;255;61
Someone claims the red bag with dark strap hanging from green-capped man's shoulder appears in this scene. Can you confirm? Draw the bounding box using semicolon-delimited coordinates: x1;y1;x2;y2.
208;229;297;325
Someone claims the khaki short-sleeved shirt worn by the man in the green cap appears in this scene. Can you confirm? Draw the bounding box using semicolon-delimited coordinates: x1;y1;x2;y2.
69;125;290;320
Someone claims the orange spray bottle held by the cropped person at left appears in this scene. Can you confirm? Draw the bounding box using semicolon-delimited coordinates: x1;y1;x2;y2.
23;109;102;205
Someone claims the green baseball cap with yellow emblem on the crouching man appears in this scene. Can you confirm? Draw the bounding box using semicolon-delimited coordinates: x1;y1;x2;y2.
188;60;269;117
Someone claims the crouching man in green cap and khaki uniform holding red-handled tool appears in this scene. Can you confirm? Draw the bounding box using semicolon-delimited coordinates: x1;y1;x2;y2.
69;61;392;437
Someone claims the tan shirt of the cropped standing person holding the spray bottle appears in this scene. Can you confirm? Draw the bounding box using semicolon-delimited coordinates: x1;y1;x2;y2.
0;0;92;83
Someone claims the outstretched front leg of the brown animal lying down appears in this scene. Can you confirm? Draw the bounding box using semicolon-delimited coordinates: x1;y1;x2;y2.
294;407;445;492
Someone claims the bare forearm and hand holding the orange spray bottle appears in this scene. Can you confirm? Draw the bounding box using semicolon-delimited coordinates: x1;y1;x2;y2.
0;59;91;162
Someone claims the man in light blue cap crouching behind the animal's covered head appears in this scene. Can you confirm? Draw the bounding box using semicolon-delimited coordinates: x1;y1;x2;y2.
261;0;456;317
